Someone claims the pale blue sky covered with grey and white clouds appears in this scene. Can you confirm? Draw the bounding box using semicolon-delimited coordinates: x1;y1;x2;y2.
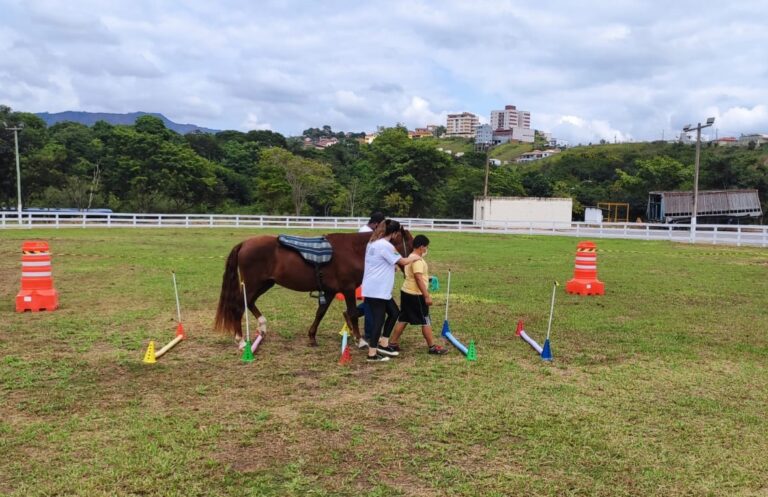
0;0;768;145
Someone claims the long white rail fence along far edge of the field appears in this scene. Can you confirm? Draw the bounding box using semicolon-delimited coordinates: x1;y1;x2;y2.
0;212;768;247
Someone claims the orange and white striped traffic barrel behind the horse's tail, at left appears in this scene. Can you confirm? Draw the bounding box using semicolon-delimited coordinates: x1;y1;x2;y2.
16;241;59;312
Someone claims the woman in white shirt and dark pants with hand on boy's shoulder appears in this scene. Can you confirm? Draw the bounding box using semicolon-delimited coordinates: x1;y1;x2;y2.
363;219;421;361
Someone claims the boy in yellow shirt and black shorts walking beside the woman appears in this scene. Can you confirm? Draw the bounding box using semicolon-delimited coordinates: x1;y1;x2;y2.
389;235;448;355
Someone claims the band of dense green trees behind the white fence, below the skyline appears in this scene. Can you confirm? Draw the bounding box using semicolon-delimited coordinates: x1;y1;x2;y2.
0;106;768;219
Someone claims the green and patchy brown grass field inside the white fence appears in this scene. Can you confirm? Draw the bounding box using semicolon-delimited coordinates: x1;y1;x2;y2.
0;229;768;496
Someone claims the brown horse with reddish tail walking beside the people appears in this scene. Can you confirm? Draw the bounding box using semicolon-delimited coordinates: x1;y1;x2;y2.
215;229;413;346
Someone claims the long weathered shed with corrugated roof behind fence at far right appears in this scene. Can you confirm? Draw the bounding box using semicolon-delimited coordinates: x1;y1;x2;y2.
646;190;763;223
